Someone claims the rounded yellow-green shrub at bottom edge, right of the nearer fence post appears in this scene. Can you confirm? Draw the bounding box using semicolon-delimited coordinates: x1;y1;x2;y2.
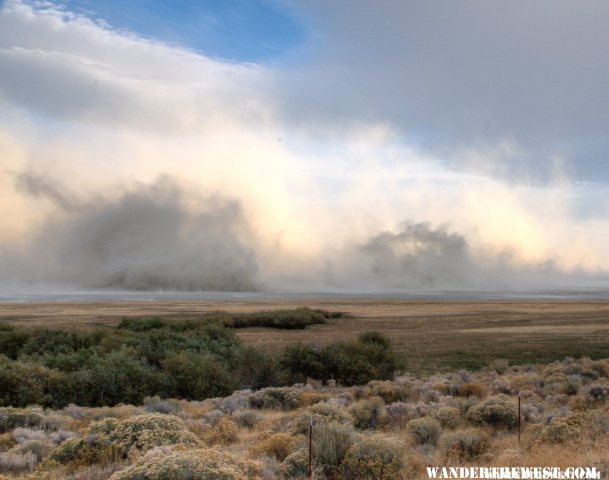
342;436;404;480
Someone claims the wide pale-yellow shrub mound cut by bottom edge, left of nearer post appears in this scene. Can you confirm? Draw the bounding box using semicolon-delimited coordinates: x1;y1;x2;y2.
110;448;260;480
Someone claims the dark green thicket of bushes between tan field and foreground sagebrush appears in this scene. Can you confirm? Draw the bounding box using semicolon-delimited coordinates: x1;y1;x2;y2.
0;318;400;408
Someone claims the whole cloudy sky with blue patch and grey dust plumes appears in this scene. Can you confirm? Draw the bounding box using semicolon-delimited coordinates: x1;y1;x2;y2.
0;0;609;292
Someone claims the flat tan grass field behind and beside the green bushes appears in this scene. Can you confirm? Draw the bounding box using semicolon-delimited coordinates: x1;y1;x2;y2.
0;300;609;374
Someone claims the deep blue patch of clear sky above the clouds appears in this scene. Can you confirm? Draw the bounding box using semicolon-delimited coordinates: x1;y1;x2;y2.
61;0;305;62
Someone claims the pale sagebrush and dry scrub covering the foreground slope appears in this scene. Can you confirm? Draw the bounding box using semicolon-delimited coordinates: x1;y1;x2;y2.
0;358;609;480
